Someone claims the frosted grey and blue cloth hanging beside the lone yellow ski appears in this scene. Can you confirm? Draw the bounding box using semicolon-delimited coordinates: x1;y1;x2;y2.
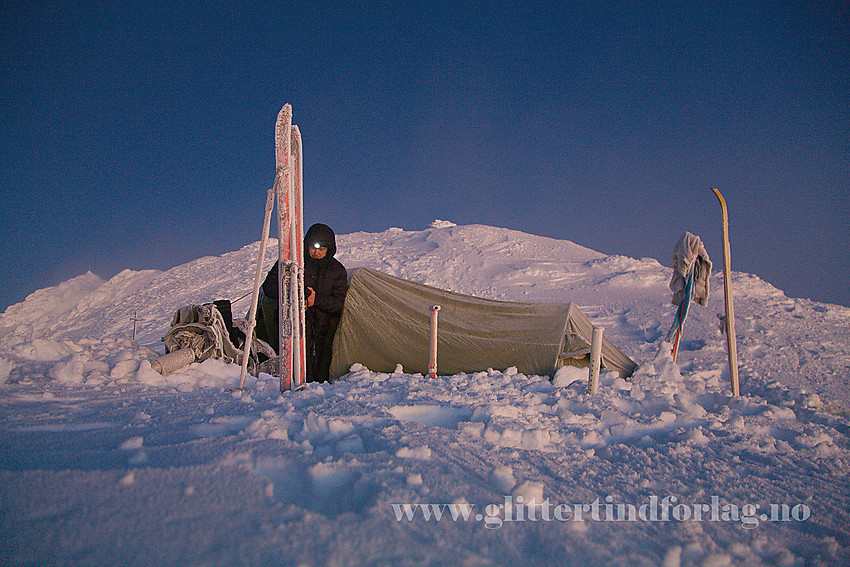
662;232;711;360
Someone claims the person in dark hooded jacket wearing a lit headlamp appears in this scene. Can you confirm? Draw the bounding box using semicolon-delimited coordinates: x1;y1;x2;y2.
257;224;348;382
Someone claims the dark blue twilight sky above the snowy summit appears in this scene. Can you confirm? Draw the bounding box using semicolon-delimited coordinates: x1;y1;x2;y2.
0;0;850;309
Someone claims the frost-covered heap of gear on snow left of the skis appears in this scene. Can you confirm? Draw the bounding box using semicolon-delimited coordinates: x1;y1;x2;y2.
162;303;275;363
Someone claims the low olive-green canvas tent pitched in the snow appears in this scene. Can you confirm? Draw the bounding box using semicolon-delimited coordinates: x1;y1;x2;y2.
331;268;637;378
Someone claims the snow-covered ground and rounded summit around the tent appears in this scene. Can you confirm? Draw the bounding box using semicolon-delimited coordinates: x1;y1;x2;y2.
0;222;850;567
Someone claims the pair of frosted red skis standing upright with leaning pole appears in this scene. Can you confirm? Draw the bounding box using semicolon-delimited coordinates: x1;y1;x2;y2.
239;104;307;391
